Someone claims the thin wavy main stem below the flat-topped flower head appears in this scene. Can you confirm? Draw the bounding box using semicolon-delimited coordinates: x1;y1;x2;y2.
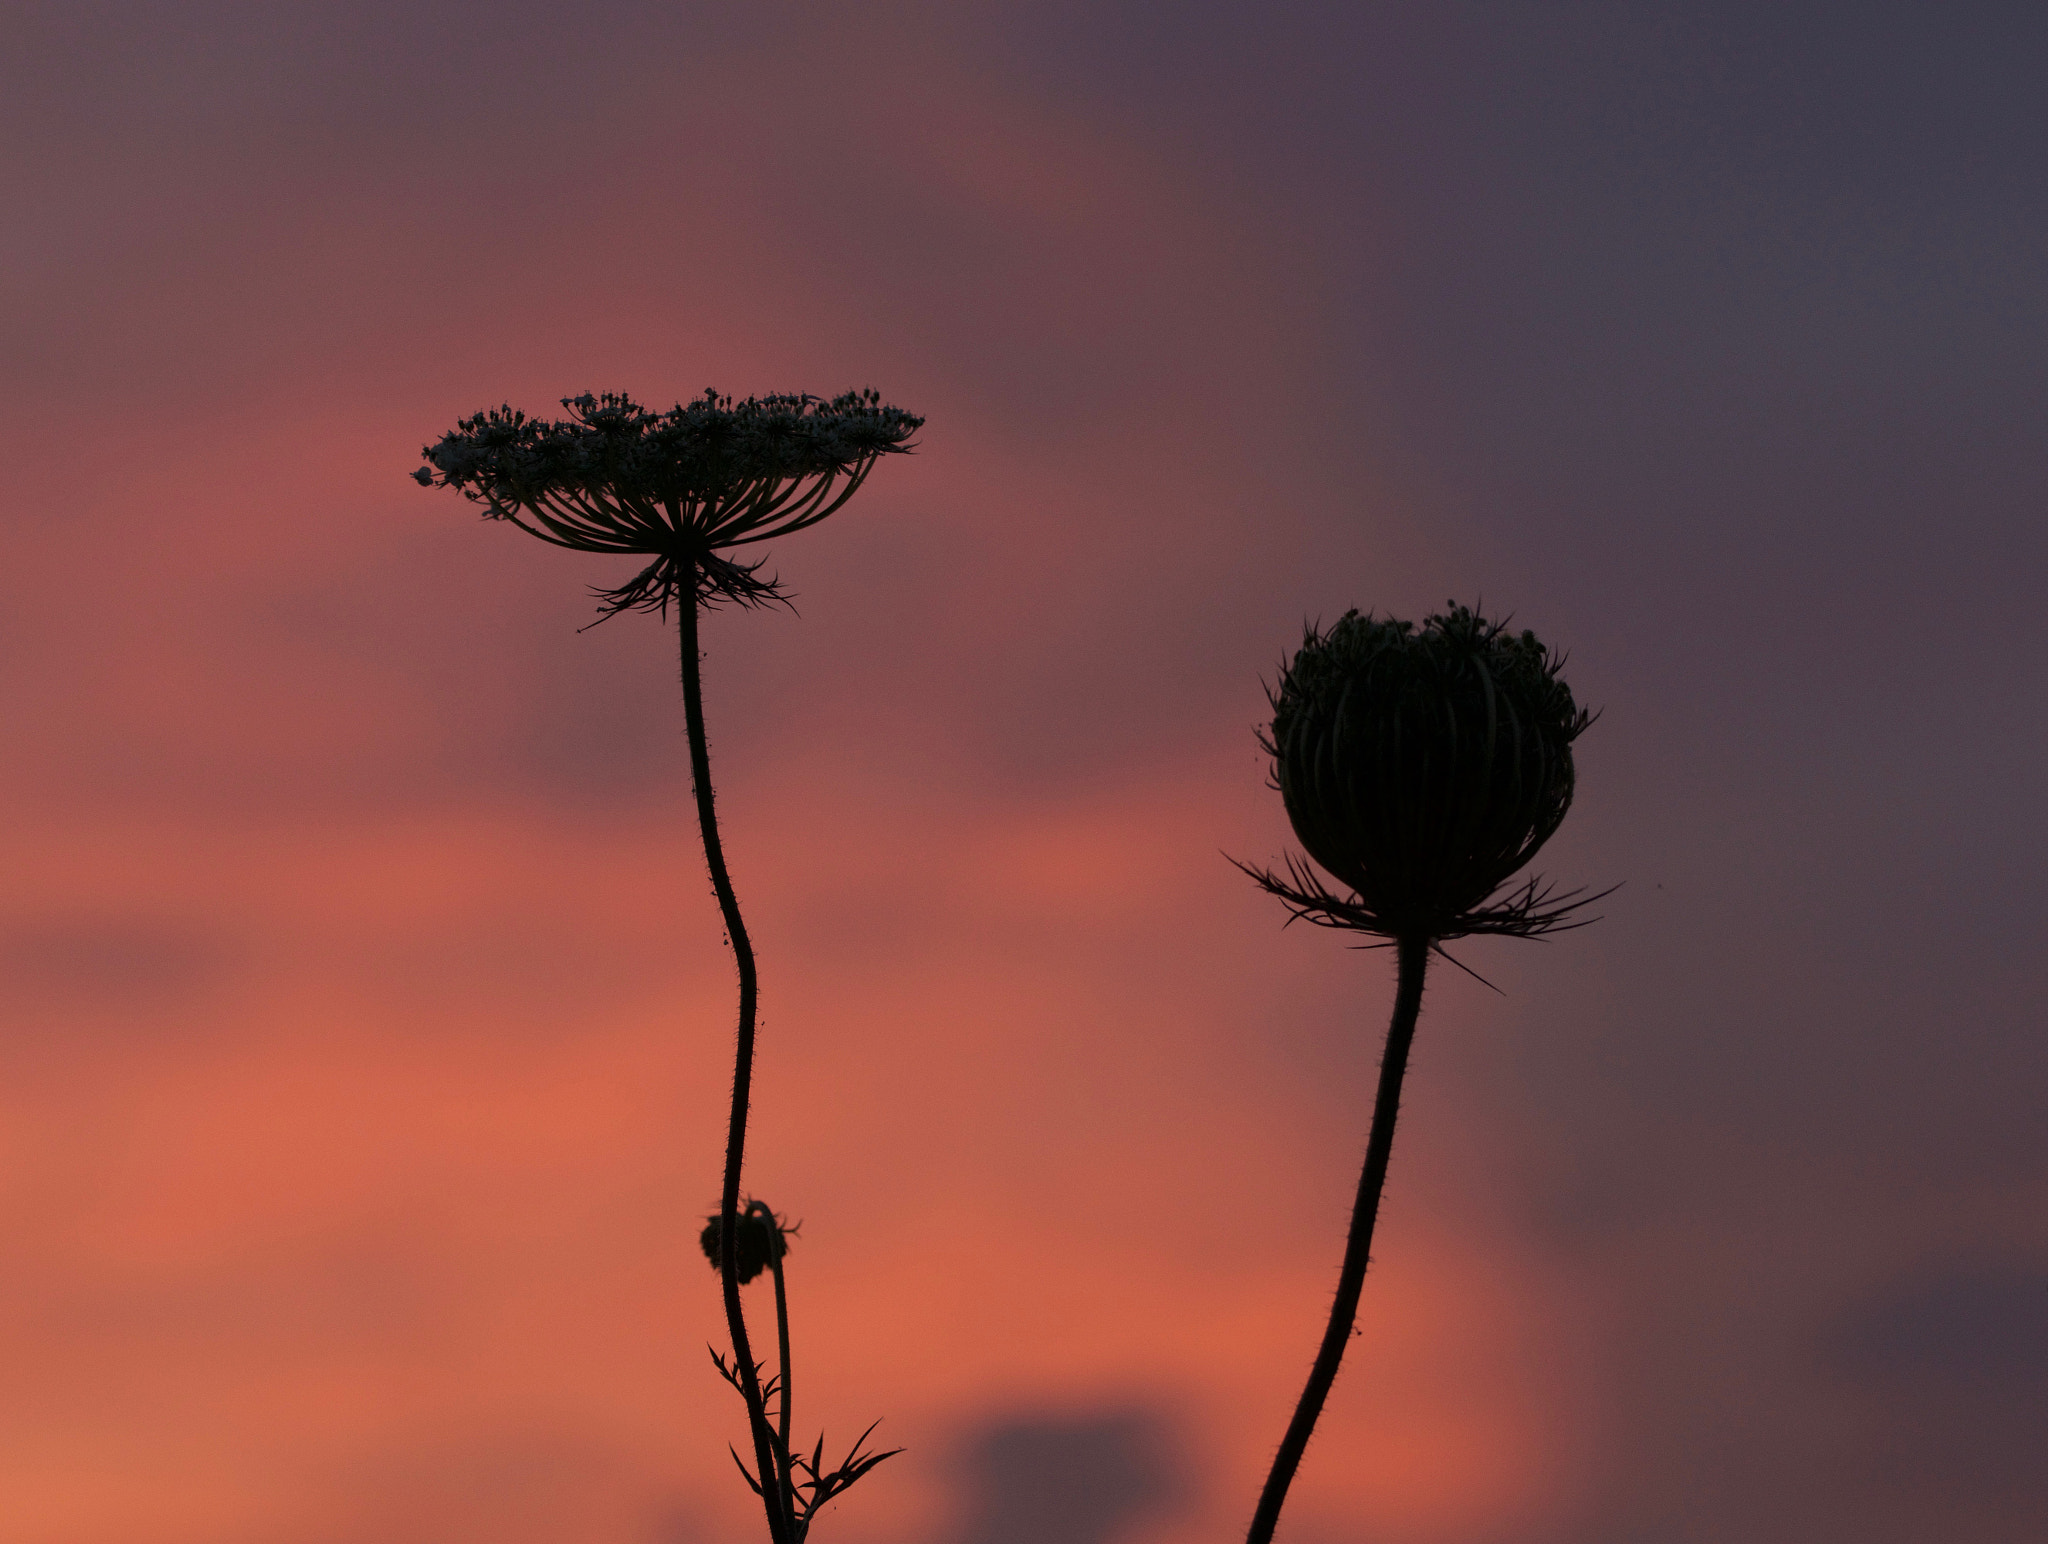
676;586;795;1544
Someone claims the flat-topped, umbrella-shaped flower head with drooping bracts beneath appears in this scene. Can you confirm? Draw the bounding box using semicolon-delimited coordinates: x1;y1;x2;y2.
414;391;924;610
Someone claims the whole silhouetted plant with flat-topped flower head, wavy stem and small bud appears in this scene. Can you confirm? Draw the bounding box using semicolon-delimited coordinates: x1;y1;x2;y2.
414;391;924;1544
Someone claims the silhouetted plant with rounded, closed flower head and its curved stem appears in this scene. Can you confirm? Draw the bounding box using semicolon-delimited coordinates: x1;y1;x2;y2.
1239;604;1606;1544
